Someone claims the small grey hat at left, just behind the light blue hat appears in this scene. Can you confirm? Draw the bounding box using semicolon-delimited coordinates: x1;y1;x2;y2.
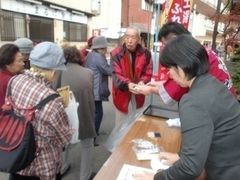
14;38;33;54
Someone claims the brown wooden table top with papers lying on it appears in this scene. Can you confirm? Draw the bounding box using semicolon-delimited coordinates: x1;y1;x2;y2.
94;115;181;180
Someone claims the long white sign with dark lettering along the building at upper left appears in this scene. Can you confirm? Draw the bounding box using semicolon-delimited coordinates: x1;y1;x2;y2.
1;0;87;24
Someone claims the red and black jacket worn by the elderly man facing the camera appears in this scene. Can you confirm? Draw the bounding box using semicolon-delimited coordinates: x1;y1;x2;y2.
111;45;152;113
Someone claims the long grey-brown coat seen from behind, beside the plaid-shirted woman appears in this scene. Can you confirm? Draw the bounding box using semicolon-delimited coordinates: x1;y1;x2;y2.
61;63;96;139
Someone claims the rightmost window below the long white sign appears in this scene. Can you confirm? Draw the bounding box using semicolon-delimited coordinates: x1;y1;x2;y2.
64;21;87;41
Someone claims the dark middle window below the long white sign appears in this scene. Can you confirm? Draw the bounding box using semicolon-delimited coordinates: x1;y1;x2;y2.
29;16;54;42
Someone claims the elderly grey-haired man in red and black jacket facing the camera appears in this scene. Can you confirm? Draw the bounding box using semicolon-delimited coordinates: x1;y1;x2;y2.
108;27;152;151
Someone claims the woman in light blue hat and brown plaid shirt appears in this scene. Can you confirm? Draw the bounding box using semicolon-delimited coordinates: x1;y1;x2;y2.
10;42;72;180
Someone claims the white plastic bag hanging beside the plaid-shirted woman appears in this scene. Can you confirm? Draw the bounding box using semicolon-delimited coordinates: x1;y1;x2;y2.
65;91;79;144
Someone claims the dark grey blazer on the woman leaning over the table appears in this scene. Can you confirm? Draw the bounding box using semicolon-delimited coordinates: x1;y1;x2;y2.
154;75;240;180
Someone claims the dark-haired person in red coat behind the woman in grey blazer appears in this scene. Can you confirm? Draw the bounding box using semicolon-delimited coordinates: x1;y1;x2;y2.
138;22;236;104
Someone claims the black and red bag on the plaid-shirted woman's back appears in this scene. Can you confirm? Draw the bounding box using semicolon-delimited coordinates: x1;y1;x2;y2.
0;79;59;173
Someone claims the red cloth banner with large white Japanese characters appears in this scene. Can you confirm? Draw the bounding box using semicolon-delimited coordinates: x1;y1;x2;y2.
167;0;192;28
